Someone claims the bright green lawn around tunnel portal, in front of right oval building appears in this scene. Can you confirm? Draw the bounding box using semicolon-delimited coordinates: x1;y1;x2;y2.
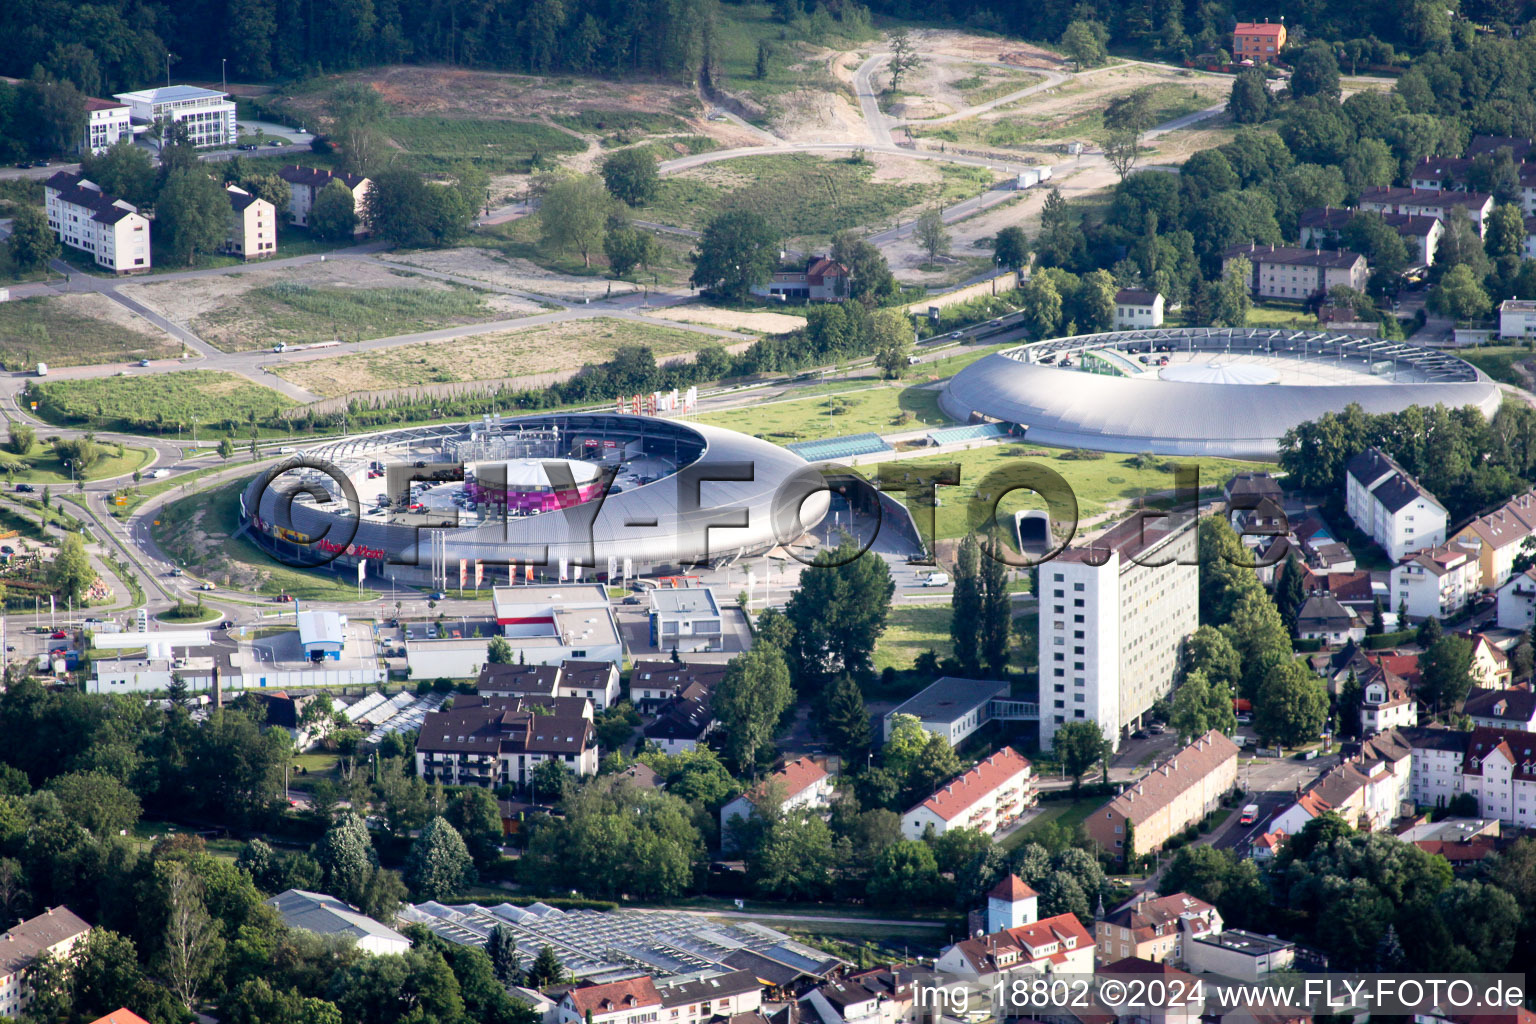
903;444;1273;540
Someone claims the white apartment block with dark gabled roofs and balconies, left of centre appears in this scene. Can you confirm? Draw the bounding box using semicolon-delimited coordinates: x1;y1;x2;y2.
416;697;598;788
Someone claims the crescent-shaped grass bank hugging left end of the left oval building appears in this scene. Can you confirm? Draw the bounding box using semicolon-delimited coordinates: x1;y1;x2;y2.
154;479;371;600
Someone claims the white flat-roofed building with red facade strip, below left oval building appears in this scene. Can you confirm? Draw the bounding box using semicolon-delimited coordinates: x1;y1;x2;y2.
492;583;624;665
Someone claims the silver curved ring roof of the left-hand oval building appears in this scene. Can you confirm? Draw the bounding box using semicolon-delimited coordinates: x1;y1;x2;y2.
243;413;829;571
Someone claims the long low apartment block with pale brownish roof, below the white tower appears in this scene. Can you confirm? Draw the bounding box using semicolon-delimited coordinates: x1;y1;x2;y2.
1084;729;1238;857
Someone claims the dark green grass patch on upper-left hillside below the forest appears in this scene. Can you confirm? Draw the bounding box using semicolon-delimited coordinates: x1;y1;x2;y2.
384;117;585;172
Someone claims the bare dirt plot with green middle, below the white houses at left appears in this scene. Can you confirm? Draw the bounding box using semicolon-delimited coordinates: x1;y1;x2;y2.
124;259;542;352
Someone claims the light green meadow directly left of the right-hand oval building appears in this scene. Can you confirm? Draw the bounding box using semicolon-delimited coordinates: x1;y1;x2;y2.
699;384;949;444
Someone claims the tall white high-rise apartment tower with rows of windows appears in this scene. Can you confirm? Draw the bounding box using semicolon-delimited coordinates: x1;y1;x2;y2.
1038;511;1200;749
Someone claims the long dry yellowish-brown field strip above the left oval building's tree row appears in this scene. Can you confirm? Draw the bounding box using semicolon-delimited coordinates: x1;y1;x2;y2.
278;317;716;398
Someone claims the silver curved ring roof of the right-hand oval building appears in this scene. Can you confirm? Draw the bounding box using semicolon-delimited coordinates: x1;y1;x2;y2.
940;329;1502;459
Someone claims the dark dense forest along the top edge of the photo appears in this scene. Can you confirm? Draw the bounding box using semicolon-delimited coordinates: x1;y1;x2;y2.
9;0;1536;103
